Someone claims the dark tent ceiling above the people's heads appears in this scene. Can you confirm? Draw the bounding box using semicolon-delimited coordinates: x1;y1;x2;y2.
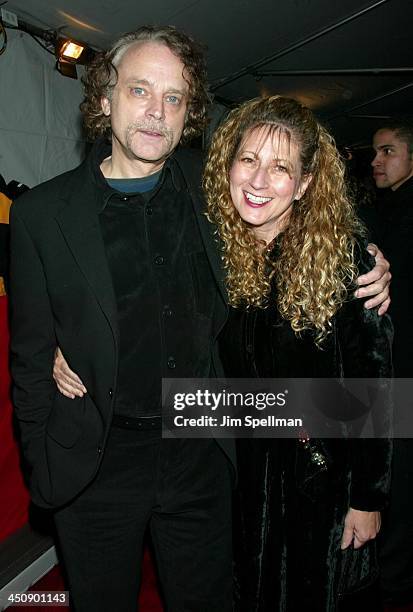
0;0;413;144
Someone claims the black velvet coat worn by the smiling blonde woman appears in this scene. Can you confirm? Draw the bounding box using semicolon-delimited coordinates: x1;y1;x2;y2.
220;241;392;612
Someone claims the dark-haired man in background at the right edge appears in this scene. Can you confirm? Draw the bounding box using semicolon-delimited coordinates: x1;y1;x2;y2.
372;119;413;605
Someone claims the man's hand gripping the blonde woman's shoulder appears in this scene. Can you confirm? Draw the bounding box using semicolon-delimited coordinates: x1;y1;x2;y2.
355;244;391;315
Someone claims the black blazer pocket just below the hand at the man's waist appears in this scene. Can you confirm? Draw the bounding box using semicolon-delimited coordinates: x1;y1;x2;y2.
46;391;87;448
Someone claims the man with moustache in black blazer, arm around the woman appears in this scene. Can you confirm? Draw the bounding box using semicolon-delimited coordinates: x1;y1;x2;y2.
11;26;386;612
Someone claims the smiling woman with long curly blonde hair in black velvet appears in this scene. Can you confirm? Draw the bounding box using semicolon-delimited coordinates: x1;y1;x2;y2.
204;96;391;612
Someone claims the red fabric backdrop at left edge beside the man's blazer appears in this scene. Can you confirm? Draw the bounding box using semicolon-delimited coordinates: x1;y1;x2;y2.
0;296;29;541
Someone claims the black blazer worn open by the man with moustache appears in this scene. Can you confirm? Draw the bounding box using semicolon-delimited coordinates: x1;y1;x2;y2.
10;150;234;507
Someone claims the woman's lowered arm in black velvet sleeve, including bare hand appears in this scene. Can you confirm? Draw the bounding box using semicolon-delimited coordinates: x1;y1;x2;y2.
337;240;393;549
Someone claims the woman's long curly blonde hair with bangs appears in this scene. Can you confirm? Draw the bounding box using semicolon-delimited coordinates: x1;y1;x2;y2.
203;96;363;344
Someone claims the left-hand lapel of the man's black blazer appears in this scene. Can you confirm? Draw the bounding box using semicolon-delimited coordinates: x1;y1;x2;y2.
56;168;118;345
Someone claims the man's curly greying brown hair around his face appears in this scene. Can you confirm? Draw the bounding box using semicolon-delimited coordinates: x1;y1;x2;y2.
80;26;209;141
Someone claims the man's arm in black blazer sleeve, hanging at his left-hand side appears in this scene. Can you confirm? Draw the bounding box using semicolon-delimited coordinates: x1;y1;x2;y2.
10;205;56;465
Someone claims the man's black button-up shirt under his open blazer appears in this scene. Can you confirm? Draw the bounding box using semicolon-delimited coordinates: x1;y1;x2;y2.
93;143;214;417
